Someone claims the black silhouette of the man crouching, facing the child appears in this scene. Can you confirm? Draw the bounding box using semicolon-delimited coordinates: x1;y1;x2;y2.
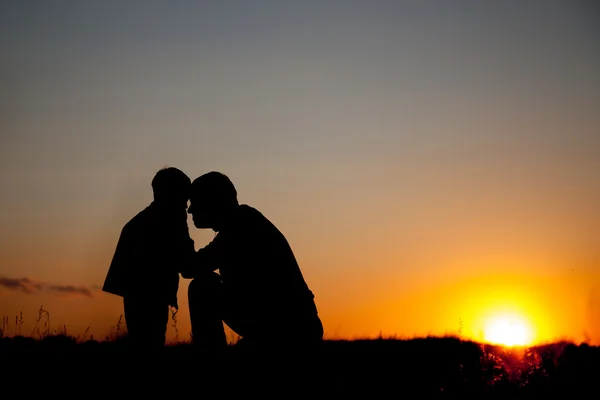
181;171;323;350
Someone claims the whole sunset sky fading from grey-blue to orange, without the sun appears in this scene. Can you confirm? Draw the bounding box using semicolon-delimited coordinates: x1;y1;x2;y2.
0;0;600;343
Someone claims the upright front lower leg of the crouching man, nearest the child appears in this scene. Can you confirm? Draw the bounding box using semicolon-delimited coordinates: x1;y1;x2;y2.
188;272;227;350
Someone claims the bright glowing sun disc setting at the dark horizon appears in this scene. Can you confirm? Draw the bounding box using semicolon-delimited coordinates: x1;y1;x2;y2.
485;316;532;346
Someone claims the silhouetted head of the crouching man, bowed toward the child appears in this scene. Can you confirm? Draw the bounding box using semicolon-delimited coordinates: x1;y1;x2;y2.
188;171;239;231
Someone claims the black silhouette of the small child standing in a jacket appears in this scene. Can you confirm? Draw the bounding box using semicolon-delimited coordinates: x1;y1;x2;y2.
102;167;195;349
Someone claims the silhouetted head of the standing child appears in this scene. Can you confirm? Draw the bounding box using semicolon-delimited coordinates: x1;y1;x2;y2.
152;167;192;209
